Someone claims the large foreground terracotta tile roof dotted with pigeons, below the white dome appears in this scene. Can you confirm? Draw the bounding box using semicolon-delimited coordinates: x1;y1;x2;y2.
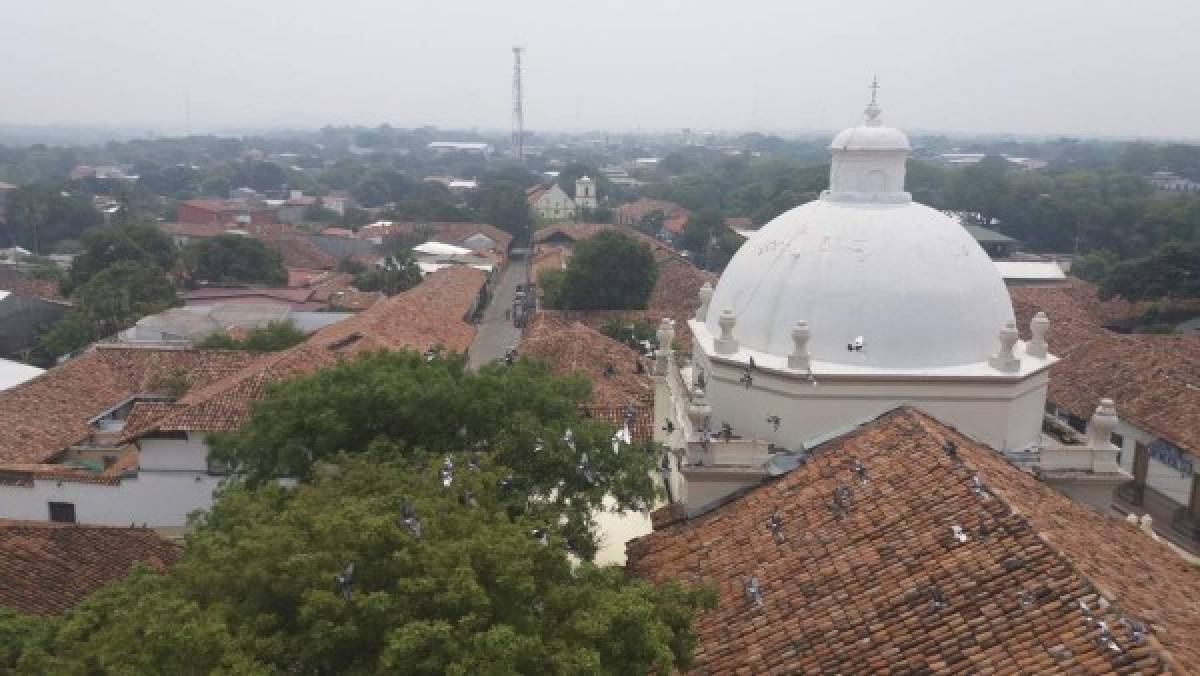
628;408;1200;674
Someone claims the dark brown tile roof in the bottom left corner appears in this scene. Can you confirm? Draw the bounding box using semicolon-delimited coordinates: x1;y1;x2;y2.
0;521;181;615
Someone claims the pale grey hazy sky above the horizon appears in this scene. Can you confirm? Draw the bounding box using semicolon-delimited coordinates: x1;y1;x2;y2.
0;0;1200;137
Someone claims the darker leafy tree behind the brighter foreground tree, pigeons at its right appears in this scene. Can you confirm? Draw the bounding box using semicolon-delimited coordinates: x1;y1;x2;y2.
211;352;655;557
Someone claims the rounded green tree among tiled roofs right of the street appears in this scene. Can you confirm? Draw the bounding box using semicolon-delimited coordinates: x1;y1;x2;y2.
562;231;659;310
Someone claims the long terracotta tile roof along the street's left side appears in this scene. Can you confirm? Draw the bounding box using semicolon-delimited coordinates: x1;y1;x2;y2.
146;267;486;431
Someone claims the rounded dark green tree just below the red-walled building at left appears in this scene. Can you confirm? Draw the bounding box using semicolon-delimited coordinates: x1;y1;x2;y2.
181;234;288;285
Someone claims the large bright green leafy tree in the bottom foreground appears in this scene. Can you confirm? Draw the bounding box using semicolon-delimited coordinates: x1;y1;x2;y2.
0;458;713;675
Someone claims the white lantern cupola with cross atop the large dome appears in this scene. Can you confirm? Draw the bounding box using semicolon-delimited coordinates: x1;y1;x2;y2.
822;82;912;204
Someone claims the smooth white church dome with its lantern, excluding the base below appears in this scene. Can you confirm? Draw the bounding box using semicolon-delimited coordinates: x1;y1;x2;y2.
706;89;1013;370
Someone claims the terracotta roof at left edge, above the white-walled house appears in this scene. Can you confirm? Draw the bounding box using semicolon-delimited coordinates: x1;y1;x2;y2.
0;346;254;465
